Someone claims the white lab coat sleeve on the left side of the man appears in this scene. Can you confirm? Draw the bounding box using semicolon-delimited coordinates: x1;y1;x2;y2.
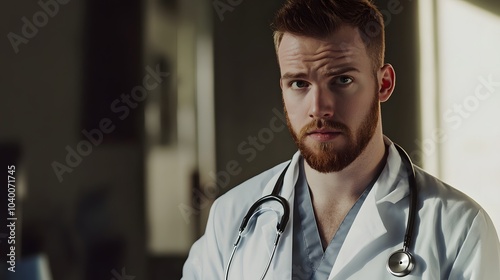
181;200;224;280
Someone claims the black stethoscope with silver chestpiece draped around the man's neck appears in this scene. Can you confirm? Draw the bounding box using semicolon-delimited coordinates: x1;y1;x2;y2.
224;144;418;280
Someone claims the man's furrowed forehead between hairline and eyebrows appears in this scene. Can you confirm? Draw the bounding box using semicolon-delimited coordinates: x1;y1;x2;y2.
278;26;370;70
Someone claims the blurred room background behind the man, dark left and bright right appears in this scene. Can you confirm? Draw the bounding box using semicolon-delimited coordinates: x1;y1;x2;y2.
0;0;500;280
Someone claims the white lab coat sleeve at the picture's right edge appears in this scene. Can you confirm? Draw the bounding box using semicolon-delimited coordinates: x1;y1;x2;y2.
448;210;500;280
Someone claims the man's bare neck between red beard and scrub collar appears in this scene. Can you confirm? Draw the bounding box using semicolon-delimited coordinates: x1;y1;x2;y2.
304;130;385;203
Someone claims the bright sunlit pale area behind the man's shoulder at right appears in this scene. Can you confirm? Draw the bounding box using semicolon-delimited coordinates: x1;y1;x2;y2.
434;0;500;236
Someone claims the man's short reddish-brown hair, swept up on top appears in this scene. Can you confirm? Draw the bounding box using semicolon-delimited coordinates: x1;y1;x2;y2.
271;0;385;73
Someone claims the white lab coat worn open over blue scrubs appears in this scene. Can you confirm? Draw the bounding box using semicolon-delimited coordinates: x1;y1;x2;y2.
182;138;500;280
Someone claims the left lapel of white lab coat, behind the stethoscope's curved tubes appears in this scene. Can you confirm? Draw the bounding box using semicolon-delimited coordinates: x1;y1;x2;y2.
261;152;300;280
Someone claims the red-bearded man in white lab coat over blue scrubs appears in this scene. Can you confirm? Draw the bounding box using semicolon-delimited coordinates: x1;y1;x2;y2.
183;0;500;280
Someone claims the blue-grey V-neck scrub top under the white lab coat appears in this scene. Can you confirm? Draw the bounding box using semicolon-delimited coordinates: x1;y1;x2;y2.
292;159;378;280
